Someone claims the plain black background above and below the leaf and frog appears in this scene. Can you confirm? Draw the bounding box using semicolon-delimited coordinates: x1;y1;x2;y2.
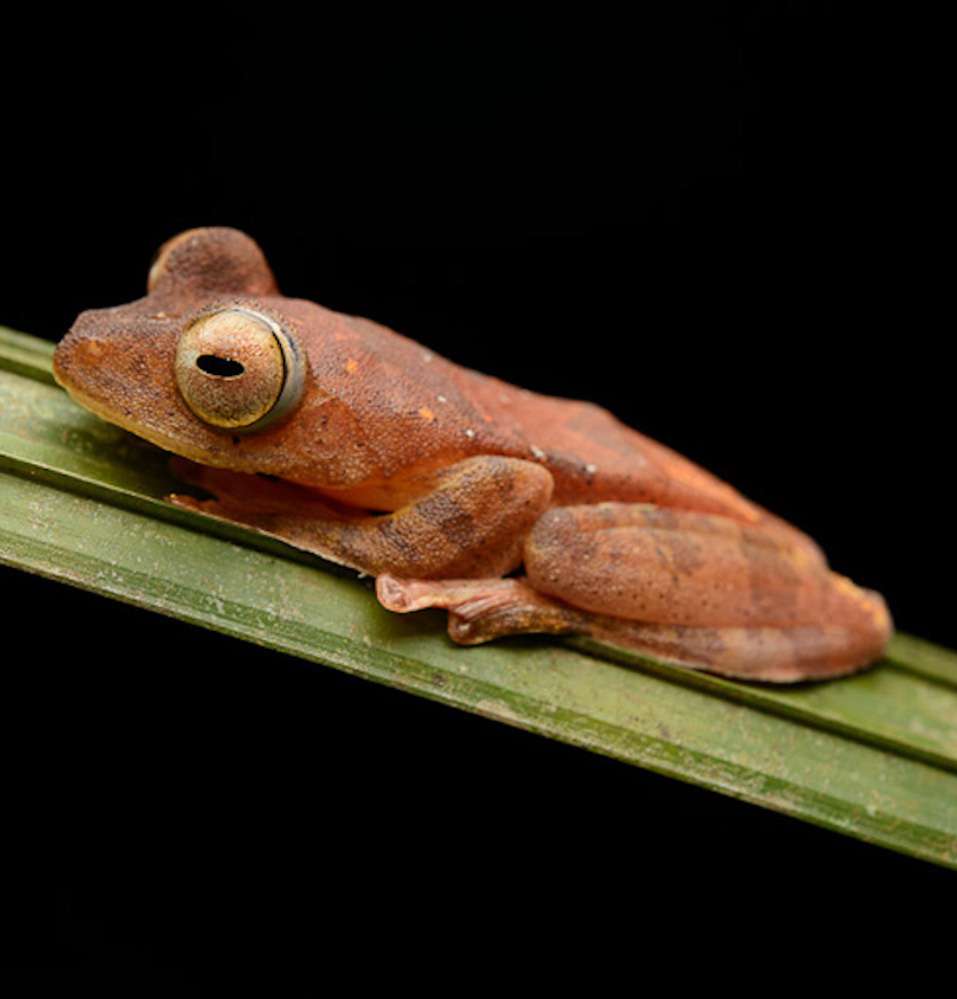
0;4;957;981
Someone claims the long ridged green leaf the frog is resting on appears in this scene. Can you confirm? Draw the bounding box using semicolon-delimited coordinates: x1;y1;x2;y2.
0;329;957;868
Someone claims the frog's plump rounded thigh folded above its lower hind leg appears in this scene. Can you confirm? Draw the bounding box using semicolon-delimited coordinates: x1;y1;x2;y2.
525;503;864;627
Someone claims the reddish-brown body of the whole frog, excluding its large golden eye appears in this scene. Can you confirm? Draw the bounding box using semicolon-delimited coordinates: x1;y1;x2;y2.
54;228;891;680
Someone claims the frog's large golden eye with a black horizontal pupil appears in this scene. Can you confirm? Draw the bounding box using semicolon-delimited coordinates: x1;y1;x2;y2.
175;307;305;433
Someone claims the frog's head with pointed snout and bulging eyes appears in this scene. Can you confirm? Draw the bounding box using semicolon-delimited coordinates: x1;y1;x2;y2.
53;228;324;470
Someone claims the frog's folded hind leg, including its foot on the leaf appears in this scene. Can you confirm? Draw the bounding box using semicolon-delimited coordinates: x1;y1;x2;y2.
377;503;891;681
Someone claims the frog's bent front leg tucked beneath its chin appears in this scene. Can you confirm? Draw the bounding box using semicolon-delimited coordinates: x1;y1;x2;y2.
172;455;553;579
